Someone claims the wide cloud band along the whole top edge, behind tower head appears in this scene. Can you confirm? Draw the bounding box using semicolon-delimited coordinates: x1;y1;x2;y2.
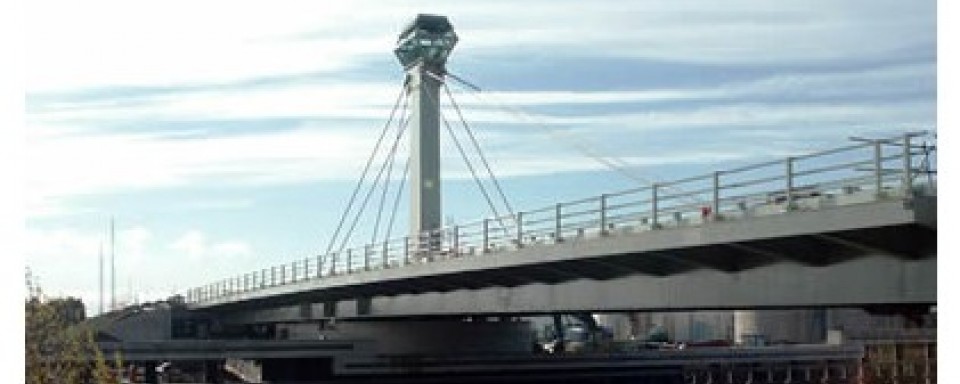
24;0;935;92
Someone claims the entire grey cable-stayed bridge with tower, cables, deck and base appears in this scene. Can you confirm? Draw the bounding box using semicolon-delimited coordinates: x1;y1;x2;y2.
86;15;937;382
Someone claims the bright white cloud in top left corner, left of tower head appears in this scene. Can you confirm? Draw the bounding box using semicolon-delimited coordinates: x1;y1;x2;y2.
24;0;392;91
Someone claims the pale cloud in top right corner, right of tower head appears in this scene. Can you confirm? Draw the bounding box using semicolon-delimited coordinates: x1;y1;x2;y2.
454;0;935;65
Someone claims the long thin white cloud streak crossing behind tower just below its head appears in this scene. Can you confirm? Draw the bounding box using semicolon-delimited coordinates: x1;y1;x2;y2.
28;64;936;130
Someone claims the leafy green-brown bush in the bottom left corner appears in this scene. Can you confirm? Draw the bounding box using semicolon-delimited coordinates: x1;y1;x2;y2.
24;268;122;384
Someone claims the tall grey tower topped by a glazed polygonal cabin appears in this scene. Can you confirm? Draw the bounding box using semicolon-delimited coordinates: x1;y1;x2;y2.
394;14;457;246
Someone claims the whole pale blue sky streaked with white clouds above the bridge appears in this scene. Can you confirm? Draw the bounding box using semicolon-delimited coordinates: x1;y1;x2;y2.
23;0;937;313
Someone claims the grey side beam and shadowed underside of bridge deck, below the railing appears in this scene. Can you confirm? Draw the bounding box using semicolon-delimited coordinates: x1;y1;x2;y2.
195;198;937;323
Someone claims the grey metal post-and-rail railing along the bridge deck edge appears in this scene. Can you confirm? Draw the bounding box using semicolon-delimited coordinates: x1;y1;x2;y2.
185;133;936;303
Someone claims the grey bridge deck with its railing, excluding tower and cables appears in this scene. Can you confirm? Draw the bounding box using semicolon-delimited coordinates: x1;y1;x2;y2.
186;130;936;320
